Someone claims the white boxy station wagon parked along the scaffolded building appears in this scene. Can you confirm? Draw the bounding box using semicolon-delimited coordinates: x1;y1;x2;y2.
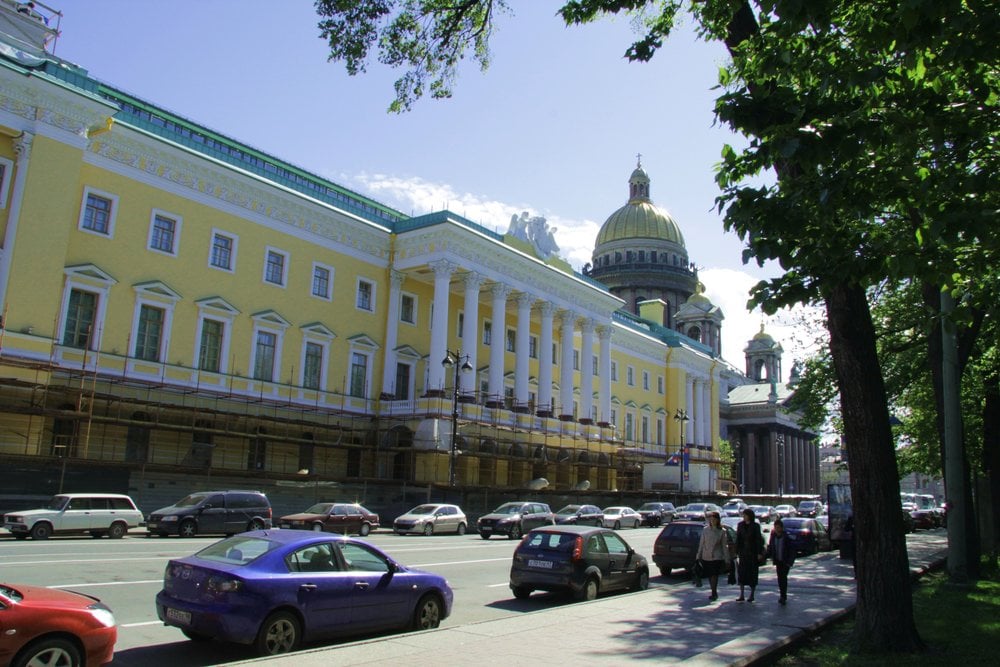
3;493;143;540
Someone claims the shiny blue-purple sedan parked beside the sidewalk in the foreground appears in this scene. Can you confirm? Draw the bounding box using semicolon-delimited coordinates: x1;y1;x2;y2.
156;530;454;655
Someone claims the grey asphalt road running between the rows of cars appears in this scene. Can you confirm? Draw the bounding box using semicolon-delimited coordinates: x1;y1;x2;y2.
0;528;685;667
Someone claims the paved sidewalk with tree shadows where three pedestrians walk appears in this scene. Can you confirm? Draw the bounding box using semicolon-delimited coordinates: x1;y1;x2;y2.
232;530;947;667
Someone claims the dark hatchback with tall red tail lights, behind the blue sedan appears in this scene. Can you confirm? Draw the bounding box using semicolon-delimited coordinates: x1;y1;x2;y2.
510;526;649;600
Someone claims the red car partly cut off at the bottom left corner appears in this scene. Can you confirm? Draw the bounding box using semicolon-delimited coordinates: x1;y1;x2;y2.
0;584;118;667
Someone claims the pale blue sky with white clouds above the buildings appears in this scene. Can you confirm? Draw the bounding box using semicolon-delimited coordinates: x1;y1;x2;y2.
46;0;802;380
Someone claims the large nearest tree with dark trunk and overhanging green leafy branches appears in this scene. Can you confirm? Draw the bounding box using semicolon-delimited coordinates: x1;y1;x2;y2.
317;0;1000;652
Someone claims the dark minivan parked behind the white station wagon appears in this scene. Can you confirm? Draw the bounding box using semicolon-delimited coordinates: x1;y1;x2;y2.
146;490;271;537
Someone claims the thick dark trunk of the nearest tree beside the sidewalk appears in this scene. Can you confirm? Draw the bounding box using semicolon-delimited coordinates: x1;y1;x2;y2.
825;283;924;653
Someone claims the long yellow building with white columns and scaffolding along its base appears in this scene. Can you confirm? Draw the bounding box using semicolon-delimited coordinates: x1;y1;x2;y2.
0;5;726;491
